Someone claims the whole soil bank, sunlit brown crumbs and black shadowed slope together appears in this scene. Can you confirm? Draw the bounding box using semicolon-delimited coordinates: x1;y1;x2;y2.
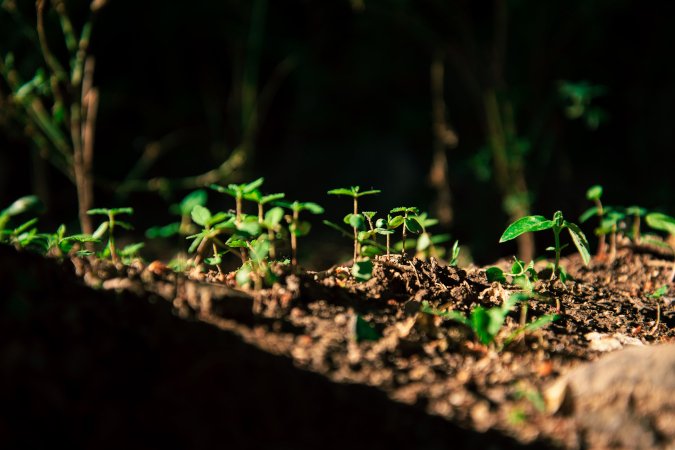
0;245;675;449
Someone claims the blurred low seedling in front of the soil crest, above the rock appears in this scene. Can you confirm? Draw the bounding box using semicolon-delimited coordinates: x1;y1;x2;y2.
420;293;560;351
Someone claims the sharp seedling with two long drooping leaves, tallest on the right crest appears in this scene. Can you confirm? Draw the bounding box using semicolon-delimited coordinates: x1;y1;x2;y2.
499;211;591;283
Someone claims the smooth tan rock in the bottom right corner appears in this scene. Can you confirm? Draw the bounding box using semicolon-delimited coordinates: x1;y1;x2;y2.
545;344;675;449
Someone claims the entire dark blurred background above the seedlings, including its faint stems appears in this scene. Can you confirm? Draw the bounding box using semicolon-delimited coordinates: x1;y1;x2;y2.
0;0;675;265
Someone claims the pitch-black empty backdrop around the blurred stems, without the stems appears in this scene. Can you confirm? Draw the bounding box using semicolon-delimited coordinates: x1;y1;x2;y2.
0;0;675;263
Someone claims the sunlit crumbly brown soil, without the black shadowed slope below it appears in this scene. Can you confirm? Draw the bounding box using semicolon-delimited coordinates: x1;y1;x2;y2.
0;246;675;449
